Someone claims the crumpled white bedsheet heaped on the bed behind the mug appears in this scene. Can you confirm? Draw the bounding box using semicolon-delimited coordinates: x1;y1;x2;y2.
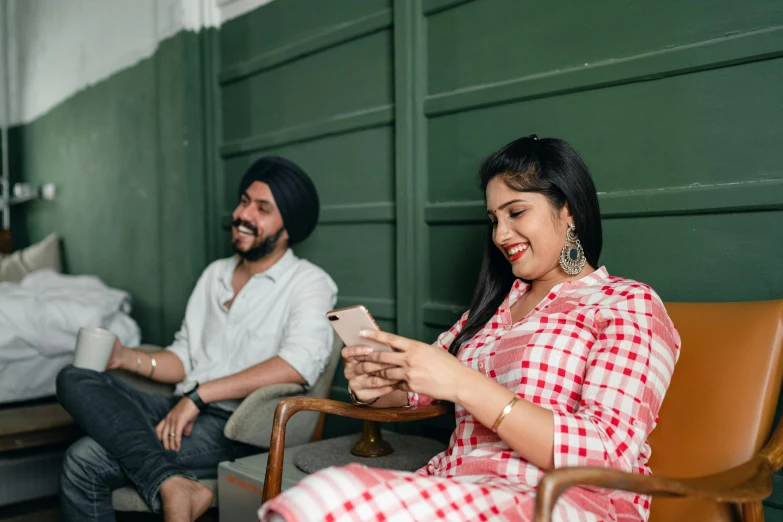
0;270;141;403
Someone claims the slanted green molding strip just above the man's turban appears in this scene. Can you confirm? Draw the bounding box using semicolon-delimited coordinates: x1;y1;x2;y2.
220;105;394;158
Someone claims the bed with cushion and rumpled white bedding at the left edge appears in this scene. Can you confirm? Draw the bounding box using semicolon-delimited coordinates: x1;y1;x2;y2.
0;234;140;506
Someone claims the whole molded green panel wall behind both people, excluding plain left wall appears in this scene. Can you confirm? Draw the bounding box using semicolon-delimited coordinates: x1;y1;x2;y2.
213;0;783;520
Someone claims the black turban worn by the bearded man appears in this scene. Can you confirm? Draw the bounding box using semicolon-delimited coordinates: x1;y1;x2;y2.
239;156;320;245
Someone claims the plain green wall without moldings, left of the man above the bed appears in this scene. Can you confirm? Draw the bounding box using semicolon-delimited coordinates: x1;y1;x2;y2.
11;30;219;345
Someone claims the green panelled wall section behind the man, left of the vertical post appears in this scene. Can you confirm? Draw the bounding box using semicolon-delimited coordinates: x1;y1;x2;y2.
215;0;399;435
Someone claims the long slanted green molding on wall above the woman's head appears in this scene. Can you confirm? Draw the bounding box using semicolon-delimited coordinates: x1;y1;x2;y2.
424;26;783;117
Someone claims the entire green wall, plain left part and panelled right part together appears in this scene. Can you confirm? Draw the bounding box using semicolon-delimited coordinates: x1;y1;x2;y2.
11;0;783;520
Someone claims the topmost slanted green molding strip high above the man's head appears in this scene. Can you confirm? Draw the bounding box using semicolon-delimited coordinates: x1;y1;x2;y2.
219;9;392;85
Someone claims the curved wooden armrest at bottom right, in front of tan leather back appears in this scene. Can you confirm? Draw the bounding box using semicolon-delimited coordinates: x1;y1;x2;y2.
533;456;775;522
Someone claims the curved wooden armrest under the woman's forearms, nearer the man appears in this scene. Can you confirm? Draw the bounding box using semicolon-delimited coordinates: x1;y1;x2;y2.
262;397;453;502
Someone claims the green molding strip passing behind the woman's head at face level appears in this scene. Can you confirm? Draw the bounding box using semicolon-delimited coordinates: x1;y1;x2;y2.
425;178;783;224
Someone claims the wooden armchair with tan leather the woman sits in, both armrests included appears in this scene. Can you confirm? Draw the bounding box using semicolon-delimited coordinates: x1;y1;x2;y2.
264;301;783;522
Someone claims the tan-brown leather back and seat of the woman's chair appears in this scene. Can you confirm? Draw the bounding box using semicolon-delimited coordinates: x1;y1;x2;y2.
649;300;783;522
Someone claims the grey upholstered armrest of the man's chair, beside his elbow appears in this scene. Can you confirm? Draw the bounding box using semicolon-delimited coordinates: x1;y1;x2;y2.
223;383;304;447
